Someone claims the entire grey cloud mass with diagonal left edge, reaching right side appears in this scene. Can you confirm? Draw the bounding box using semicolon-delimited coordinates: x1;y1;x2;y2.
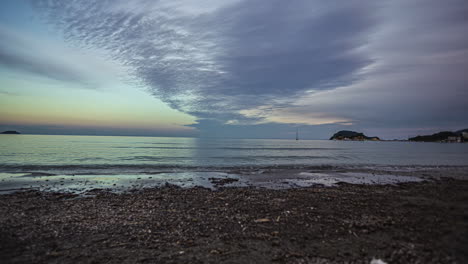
27;0;468;138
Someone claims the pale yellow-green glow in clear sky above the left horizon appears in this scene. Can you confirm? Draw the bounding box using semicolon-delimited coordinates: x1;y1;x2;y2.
0;75;195;131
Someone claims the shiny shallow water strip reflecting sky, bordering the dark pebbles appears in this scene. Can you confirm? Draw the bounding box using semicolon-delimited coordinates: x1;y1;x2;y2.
0;171;424;194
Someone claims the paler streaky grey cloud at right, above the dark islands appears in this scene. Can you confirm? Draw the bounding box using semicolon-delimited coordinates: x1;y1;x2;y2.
236;0;468;133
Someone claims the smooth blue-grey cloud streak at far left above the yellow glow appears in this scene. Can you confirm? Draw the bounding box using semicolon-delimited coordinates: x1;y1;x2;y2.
0;25;128;89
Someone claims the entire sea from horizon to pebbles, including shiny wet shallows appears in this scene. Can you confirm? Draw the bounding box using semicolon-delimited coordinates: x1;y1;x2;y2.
0;135;468;193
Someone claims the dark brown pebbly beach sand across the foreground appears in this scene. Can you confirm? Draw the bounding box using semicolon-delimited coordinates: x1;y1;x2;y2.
0;178;468;263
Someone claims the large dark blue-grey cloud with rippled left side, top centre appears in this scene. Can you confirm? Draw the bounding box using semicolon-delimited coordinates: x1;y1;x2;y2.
29;0;374;117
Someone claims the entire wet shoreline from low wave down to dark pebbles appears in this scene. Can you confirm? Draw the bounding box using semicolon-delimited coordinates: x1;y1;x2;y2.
0;165;468;195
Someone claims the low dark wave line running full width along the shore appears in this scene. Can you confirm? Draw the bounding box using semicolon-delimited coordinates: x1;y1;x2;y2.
0;161;468;175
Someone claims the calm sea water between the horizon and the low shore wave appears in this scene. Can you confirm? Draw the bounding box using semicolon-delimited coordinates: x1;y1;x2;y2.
0;135;468;171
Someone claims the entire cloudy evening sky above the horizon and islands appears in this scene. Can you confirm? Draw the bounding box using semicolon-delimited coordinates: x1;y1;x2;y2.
0;0;468;139
